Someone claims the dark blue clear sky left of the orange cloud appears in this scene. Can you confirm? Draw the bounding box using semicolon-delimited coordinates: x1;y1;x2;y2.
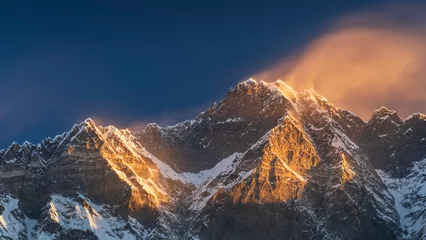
0;1;386;148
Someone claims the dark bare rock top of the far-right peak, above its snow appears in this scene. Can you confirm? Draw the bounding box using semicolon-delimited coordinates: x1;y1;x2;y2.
358;107;426;177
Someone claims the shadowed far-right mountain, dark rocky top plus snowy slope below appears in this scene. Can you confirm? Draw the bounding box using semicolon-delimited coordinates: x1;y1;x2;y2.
360;107;426;239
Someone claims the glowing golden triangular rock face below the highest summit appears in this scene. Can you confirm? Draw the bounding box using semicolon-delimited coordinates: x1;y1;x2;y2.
226;116;320;204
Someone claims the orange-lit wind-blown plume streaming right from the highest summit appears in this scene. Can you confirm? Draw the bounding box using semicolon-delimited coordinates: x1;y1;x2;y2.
256;5;426;120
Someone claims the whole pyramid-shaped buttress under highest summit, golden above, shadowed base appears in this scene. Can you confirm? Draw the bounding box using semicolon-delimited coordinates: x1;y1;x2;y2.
186;83;400;239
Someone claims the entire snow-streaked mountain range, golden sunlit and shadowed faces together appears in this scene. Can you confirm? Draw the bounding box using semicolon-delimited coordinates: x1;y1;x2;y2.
0;79;426;239
